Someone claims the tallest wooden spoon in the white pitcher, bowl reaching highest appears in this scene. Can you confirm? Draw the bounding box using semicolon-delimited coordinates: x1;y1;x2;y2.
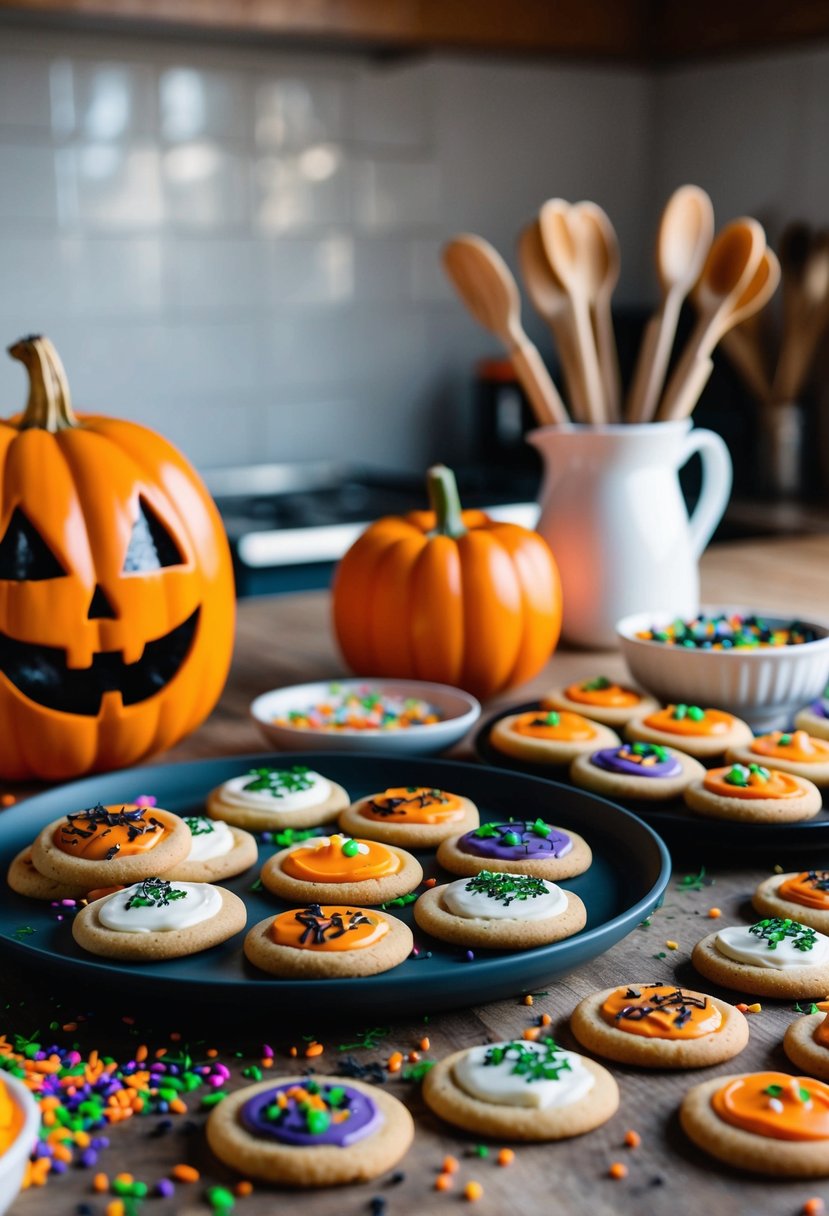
626;186;714;422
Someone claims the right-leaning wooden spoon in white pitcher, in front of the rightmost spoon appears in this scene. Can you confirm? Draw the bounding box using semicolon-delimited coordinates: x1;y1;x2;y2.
656;219;763;422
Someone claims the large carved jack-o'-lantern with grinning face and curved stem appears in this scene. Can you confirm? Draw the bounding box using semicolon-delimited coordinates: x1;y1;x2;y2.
0;338;233;779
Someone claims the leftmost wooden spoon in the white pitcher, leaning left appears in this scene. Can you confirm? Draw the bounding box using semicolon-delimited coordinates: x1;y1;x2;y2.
442;233;568;427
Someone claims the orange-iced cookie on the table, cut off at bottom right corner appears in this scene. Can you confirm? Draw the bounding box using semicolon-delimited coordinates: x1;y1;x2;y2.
679;1071;829;1178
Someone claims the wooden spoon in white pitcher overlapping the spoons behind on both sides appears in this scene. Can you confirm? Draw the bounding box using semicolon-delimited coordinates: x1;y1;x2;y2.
538;198;607;424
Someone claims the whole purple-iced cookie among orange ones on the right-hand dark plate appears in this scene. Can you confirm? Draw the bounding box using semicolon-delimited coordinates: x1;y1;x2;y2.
570;741;705;803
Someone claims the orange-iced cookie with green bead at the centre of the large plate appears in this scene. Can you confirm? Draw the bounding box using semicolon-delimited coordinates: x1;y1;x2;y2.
261;833;423;907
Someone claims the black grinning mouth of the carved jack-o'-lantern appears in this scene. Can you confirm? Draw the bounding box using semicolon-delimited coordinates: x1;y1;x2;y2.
0;608;201;716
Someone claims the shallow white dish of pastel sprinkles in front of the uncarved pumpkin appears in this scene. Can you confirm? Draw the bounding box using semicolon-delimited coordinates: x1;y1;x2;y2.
250;677;480;756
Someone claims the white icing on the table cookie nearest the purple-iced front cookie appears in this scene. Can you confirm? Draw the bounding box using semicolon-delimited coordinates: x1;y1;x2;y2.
453;1041;594;1110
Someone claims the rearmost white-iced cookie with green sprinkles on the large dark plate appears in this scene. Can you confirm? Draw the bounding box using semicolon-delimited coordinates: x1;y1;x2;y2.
207;765;351;832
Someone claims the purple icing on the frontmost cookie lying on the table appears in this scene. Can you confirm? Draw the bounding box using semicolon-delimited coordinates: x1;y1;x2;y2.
239;1081;384;1148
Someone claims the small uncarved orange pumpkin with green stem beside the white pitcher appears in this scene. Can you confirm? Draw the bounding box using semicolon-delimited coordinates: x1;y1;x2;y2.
333;465;562;697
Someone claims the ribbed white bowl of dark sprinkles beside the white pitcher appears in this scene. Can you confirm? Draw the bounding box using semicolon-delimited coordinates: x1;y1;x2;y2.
616;604;829;733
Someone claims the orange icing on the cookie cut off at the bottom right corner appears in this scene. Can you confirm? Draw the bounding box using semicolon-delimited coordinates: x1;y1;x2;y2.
711;1073;829;1141
